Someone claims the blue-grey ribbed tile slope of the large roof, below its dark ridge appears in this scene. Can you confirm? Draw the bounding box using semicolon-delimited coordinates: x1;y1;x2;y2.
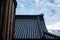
14;19;40;38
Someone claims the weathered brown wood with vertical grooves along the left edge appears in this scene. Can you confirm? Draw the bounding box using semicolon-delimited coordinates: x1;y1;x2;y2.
0;0;16;40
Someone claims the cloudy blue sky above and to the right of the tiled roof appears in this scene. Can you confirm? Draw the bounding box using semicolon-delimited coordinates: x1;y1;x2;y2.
16;0;60;35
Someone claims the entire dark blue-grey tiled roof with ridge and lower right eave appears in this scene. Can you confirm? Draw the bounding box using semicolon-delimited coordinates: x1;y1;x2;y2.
13;14;60;40
